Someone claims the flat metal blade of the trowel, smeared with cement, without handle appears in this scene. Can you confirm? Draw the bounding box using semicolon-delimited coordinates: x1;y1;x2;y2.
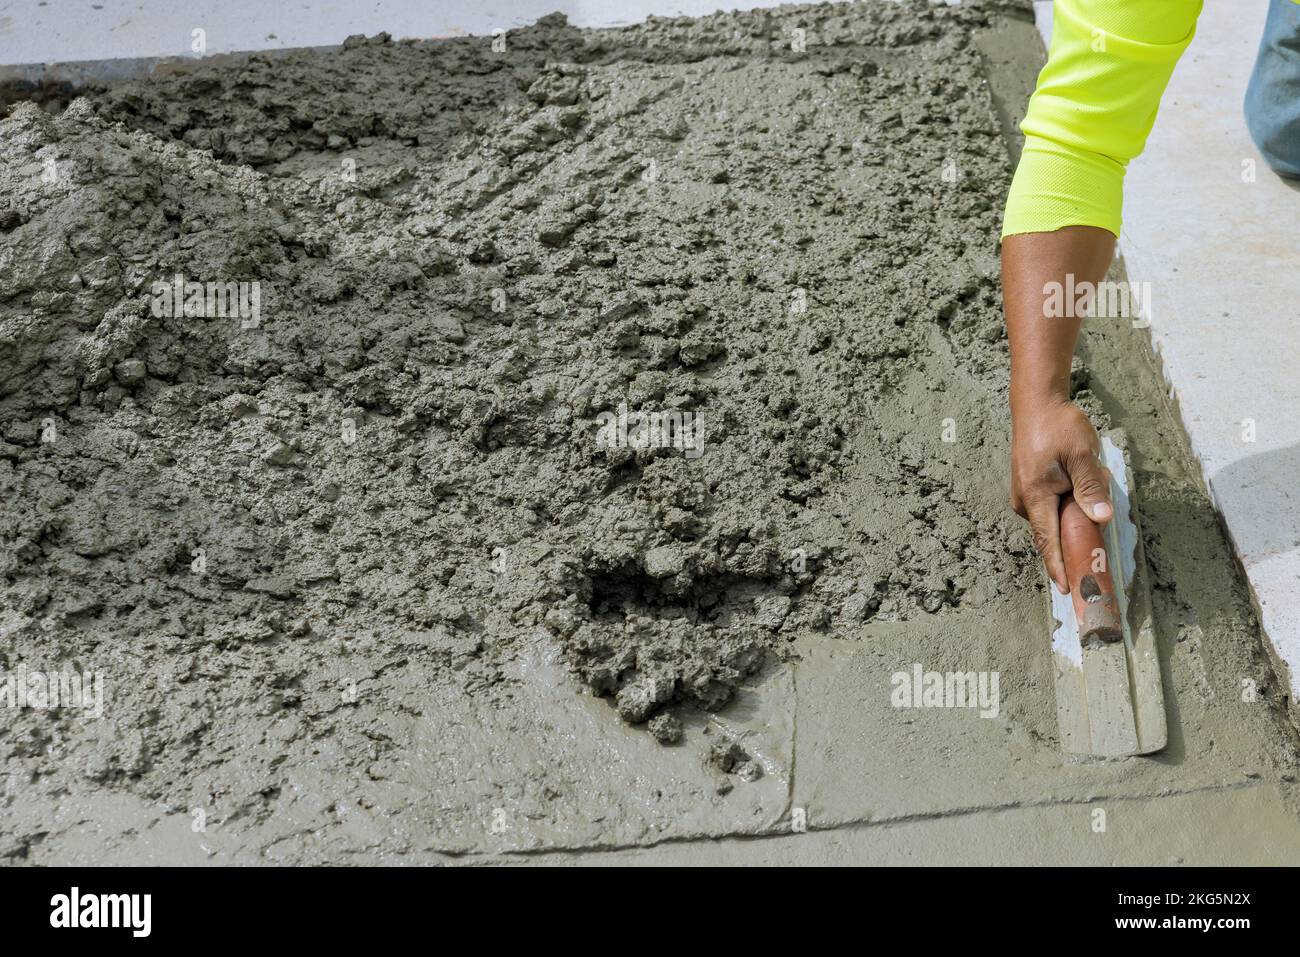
1048;433;1169;757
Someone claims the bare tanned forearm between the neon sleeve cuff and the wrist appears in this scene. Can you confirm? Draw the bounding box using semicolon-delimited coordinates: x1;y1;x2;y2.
1002;226;1115;423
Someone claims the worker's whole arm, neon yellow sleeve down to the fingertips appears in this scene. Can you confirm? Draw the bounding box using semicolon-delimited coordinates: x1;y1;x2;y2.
1002;0;1201;582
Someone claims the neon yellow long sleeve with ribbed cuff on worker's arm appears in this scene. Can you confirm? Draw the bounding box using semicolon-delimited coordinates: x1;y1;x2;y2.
1002;0;1201;237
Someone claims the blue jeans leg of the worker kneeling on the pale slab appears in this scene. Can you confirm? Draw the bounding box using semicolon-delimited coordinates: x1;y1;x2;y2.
1245;0;1300;177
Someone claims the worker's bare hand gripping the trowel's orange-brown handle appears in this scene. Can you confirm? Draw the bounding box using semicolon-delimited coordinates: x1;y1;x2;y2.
1011;400;1114;594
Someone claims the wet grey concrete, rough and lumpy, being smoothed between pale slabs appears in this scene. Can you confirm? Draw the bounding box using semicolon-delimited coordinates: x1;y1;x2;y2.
0;0;1300;863
